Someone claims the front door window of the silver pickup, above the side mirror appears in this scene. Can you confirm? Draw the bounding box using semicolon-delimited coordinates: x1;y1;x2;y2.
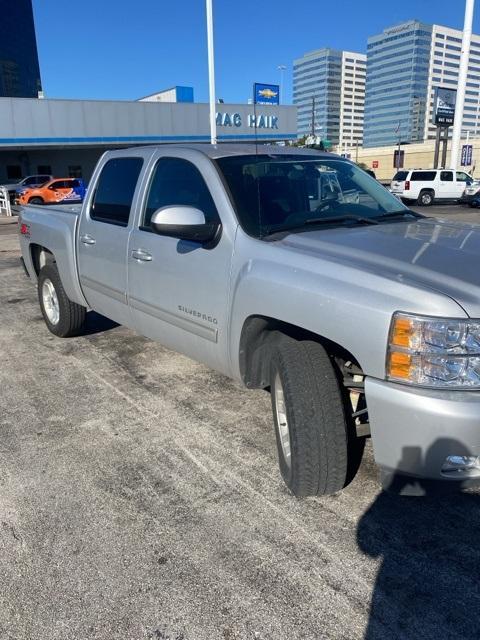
143;158;218;228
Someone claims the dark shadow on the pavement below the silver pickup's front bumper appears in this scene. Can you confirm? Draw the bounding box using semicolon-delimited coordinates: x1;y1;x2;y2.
357;439;480;640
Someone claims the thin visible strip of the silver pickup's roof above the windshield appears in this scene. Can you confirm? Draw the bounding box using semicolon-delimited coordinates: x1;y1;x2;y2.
127;142;340;159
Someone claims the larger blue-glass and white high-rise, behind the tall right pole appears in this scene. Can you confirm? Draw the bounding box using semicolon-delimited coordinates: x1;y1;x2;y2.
364;20;480;147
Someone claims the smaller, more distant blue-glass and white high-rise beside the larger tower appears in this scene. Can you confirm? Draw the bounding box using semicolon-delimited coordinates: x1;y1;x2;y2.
293;48;366;151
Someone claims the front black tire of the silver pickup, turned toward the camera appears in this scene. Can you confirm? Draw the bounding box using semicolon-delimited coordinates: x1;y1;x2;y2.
270;335;350;496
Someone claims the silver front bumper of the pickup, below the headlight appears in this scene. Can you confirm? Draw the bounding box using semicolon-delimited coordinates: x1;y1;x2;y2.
365;378;480;481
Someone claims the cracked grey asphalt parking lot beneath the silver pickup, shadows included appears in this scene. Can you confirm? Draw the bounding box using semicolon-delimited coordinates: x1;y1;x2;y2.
0;207;480;640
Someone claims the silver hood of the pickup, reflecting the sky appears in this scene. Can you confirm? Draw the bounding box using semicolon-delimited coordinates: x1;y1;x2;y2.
281;218;480;318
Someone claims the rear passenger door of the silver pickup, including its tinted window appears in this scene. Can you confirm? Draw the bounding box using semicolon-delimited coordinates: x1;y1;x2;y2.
77;151;144;326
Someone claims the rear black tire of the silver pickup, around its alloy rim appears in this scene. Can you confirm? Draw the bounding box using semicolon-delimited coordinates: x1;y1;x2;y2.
38;262;86;338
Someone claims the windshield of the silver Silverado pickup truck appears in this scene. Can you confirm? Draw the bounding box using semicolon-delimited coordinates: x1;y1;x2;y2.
217;155;408;238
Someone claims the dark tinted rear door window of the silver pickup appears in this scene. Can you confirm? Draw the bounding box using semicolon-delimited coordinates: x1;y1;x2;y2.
90;158;143;227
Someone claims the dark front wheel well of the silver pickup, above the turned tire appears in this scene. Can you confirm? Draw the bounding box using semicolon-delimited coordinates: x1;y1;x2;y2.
239;316;362;389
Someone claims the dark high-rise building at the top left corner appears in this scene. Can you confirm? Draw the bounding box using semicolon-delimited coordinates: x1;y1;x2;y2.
0;0;42;98
